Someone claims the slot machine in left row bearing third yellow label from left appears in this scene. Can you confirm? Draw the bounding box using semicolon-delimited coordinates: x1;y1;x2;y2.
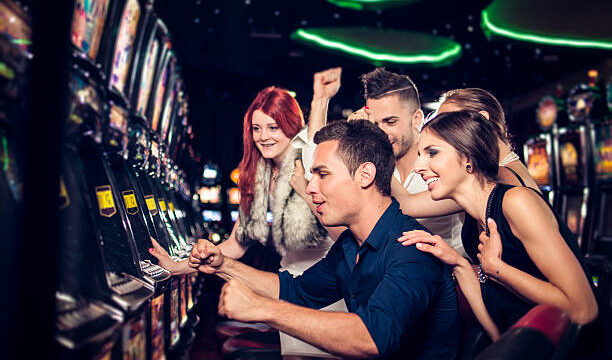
128;19;189;357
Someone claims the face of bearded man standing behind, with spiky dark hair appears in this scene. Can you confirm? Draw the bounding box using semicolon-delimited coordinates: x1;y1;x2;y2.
366;95;417;159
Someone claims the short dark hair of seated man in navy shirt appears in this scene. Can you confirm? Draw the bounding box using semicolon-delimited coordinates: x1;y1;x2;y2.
314;120;395;196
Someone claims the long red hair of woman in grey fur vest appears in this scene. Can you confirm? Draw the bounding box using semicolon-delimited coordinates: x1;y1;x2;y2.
238;86;304;214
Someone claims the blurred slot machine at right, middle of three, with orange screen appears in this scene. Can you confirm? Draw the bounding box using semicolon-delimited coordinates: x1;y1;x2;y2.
539;91;590;249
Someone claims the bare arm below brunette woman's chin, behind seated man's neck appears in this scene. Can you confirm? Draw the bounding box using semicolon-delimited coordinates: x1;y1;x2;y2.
391;178;463;218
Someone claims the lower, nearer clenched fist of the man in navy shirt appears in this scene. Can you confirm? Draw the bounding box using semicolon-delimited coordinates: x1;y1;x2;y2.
218;280;269;322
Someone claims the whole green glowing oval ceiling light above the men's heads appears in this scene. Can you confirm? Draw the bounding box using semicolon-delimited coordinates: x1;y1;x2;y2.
292;28;461;66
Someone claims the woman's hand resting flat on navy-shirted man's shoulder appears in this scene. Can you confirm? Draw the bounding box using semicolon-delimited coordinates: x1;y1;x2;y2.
397;230;464;266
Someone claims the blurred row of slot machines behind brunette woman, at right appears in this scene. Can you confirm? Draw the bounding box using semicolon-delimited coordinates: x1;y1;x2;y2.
524;71;612;316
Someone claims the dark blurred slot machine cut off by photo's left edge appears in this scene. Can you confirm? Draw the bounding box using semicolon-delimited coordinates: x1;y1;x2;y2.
0;0;30;358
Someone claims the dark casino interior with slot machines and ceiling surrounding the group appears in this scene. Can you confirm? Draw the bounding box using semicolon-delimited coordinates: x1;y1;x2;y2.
0;0;612;360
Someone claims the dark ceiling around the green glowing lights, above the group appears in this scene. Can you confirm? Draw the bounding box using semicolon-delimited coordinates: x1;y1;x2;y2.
155;0;610;173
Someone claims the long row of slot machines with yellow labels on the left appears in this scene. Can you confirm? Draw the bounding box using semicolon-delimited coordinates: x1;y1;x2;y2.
52;0;201;359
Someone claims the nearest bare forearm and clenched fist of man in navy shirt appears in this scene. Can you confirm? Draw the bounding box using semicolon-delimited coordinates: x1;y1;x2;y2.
219;280;378;358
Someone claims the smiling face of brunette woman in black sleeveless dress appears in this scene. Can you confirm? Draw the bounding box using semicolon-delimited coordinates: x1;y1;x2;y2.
414;129;468;200
